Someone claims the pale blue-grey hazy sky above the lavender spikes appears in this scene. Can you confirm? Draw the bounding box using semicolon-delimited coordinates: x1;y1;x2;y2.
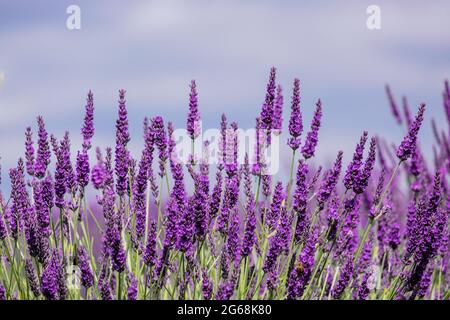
0;0;450;188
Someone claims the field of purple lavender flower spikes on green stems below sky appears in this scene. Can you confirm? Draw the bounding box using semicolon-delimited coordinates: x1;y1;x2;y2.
0;68;450;300
